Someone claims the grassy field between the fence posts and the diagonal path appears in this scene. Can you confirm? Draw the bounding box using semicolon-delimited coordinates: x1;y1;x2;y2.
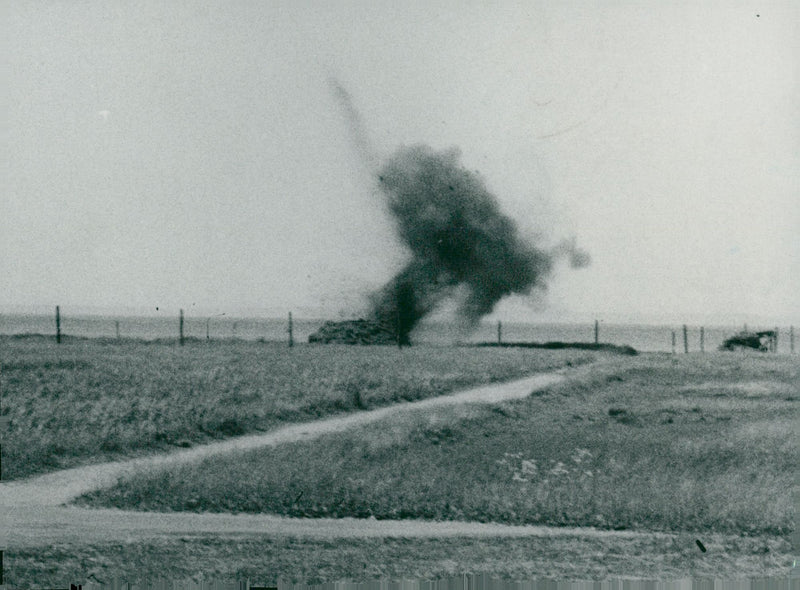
0;337;597;480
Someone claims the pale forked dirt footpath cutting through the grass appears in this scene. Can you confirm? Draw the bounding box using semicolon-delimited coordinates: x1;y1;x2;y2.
0;370;669;549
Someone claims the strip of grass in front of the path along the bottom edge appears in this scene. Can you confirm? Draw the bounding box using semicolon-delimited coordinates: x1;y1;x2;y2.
5;534;792;588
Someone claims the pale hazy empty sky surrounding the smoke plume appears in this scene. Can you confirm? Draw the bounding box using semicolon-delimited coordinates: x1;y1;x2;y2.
0;0;800;323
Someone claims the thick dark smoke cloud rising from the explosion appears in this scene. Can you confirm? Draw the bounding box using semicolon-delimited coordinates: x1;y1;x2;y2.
373;145;554;343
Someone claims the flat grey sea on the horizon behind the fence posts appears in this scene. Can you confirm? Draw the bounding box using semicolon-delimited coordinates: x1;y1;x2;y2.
0;314;789;352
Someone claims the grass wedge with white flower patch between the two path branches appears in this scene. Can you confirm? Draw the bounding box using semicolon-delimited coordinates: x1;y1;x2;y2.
78;349;800;535
